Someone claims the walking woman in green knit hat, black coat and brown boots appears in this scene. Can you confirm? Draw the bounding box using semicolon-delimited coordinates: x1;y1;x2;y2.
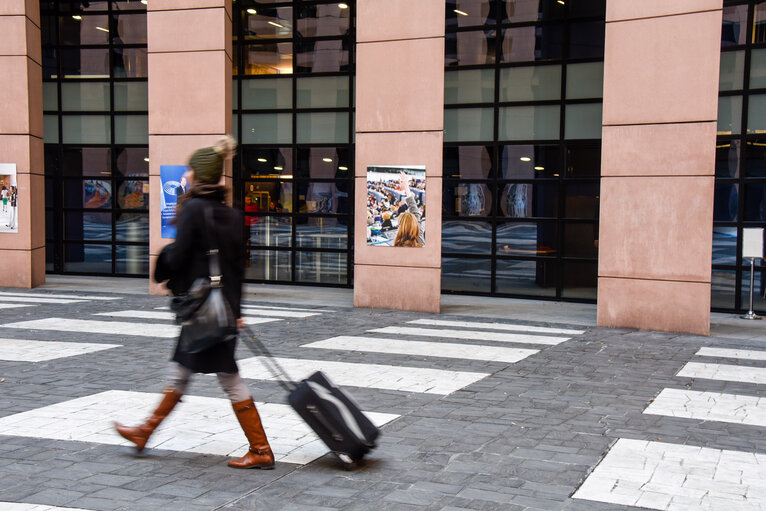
115;137;274;469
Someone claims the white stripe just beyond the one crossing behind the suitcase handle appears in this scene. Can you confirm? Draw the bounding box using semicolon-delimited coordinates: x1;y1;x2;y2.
302;335;539;364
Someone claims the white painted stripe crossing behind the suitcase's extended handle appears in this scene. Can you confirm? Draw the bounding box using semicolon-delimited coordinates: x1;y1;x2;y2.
237;357;489;396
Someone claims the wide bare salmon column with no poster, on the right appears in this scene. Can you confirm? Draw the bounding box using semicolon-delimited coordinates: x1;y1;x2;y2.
598;0;722;335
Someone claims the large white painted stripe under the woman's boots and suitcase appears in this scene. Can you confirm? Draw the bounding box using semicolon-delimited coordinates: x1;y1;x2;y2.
0;390;399;463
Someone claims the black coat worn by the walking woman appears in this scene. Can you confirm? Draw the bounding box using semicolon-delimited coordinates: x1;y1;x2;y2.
154;193;245;373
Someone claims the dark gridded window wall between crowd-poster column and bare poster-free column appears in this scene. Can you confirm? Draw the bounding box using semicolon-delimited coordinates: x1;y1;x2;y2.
442;0;605;301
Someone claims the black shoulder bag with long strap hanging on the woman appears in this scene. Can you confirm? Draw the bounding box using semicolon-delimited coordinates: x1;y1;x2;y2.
170;206;237;353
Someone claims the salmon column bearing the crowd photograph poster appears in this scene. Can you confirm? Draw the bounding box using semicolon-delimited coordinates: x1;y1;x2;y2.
354;0;444;312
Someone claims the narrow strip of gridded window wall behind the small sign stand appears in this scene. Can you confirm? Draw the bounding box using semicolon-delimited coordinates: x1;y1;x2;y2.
711;0;766;313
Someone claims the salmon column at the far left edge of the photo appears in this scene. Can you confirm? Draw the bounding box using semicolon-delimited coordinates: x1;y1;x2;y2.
0;0;45;288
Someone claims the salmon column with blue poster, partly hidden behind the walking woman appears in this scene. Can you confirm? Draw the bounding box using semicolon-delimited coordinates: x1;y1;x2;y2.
147;0;232;294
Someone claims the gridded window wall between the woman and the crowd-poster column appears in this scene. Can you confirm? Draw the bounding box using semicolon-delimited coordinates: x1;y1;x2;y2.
233;0;355;286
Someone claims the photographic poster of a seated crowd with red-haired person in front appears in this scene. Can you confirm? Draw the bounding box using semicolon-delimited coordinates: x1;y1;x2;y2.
367;165;426;247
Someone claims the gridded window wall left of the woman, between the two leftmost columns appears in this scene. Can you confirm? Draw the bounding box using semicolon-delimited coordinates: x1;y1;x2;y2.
40;0;149;276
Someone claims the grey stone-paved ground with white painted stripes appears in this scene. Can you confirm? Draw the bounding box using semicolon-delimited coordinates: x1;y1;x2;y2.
0;277;766;511
